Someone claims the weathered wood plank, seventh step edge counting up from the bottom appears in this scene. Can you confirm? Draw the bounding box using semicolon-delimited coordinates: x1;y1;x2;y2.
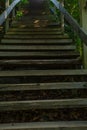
0;45;76;51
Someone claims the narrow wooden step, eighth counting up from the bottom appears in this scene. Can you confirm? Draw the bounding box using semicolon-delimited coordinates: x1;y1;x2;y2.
1;39;72;45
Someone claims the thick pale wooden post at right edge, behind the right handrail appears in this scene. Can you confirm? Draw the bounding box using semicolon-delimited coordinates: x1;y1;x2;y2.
80;0;87;69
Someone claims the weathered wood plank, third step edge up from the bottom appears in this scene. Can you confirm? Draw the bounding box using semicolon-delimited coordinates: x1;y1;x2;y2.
0;82;87;92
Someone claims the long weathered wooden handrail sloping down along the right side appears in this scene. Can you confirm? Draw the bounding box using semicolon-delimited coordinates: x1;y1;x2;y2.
50;0;87;45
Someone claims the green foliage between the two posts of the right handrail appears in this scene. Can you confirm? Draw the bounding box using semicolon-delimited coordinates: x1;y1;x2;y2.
65;0;82;55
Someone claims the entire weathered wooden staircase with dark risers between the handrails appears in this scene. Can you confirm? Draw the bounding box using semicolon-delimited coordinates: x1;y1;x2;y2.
0;2;87;130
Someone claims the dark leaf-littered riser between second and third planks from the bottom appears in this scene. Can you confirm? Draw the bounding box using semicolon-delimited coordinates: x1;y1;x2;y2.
0;89;87;102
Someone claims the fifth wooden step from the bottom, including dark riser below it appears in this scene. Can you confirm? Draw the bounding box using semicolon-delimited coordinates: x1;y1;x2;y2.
0;57;82;70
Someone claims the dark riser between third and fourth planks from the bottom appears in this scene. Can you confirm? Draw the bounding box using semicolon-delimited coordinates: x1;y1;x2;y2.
0;74;87;84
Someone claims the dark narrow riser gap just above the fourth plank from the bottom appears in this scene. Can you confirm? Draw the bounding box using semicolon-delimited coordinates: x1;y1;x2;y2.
0;64;81;70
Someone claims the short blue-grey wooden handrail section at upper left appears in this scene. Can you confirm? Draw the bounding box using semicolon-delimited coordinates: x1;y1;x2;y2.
0;0;21;25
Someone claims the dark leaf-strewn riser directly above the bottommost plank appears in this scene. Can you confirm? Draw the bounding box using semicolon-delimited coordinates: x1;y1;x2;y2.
0;108;87;123
